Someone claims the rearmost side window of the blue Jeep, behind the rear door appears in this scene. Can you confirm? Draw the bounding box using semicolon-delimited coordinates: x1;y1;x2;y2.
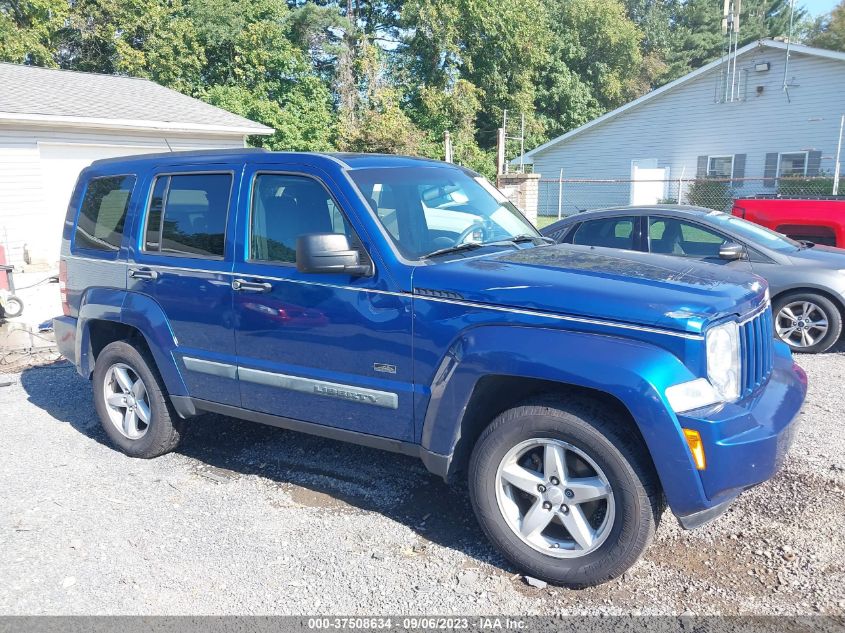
73;176;135;252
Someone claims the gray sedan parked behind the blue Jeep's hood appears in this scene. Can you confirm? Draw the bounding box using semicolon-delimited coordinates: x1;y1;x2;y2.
541;205;845;352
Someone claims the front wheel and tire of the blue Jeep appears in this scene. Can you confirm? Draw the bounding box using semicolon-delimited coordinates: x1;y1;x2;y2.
469;398;663;588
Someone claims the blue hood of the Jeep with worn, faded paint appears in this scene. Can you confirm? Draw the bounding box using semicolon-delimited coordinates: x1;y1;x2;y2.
413;244;767;332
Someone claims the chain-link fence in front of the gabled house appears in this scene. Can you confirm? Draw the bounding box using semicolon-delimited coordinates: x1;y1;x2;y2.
537;176;833;218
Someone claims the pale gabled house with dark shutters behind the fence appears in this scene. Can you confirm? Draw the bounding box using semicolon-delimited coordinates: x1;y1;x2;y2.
513;40;845;215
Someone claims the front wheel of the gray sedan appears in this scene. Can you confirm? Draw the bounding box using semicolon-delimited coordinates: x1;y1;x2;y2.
772;291;842;354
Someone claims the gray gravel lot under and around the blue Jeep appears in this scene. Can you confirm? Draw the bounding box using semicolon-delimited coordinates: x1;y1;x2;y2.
0;345;845;615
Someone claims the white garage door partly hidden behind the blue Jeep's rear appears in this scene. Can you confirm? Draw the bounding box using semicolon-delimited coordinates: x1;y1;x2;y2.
34;143;166;263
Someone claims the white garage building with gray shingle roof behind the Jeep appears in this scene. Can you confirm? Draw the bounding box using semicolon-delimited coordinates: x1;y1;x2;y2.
0;64;273;264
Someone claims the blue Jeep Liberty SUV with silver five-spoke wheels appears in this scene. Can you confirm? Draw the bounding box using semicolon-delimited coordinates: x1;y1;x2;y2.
55;150;806;587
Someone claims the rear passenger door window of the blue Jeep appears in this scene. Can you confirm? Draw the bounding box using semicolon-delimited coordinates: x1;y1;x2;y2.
144;173;232;259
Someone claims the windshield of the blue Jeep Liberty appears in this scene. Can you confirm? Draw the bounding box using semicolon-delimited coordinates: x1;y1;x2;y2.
349;166;542;259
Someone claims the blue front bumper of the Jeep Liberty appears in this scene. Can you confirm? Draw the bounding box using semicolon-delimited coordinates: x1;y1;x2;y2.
676;343;807;527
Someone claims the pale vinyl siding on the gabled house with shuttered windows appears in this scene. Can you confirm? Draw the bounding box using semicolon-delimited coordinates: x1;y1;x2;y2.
534;48;845;215
